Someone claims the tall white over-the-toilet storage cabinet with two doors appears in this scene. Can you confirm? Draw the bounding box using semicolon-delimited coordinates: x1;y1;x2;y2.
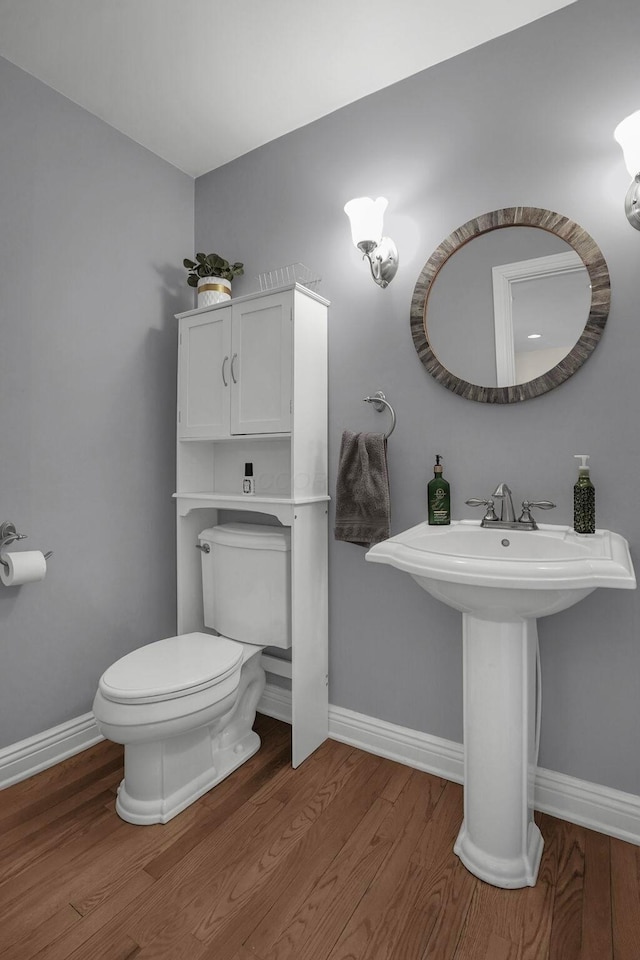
175;284;329;767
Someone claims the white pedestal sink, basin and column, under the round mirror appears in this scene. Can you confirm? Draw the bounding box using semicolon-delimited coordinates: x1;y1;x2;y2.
366;520;636;888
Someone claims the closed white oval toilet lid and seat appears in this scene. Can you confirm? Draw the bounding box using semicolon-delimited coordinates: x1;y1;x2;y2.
99;633;242;703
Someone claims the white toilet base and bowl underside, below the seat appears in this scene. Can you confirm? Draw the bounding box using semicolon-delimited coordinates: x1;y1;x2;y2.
116;656;265;824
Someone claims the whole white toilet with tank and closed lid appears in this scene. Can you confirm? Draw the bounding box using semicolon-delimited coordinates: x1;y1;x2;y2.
93;523;291;824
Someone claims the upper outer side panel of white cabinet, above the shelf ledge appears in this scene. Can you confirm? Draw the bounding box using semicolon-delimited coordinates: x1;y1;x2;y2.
292;291;328;497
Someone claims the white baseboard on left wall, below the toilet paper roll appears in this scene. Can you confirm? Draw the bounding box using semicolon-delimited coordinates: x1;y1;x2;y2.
0;713;103;790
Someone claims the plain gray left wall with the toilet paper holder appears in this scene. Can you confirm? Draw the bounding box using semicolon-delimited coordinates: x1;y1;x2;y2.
0;59;194;746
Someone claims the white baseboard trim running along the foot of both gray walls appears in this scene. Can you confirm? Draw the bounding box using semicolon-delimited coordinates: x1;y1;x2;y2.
5;683;640;845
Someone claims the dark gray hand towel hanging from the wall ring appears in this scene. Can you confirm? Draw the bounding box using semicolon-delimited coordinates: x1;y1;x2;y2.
334;430;391;547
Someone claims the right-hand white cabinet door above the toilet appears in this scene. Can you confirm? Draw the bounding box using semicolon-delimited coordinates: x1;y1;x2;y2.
230;294;293;434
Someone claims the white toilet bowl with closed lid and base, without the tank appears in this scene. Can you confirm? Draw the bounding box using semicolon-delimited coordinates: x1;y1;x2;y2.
93;633;265;824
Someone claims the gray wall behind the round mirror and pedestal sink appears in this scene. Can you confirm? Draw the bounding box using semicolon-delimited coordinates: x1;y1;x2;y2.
196;0;640;794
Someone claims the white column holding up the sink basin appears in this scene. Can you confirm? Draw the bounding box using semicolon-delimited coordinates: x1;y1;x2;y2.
454;613;543;888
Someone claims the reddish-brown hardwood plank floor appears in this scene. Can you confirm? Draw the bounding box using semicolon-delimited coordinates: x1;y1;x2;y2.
0;716;640;960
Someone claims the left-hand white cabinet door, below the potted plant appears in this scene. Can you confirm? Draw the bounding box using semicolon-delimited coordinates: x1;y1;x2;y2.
178;307;231;438
